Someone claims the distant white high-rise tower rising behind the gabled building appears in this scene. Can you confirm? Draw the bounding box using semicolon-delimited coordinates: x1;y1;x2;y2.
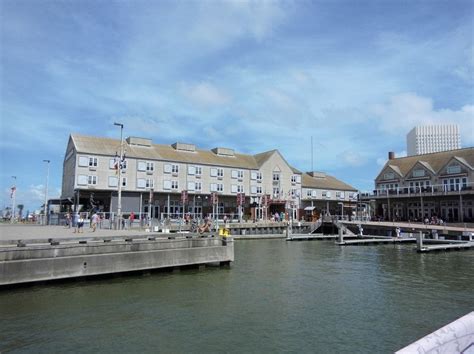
407;124;461;156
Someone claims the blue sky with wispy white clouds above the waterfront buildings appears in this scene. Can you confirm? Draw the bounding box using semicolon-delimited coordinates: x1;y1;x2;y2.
0;0;474;210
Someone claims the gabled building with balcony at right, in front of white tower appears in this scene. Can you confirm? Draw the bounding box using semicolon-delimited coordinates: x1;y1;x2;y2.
361;148;474;222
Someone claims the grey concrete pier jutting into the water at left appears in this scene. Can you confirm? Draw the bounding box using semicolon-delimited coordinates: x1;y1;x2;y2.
0;227;234;286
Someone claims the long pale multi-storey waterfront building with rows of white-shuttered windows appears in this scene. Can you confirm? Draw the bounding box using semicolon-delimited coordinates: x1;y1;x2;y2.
62;134;357;220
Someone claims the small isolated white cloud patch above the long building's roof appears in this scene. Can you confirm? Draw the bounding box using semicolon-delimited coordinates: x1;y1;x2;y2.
181;82;231;107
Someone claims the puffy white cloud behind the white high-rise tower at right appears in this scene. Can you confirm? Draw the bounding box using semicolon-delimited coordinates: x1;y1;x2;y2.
371;93;474;145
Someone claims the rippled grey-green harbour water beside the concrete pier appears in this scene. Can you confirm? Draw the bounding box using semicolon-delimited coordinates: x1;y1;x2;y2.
0;240;474;353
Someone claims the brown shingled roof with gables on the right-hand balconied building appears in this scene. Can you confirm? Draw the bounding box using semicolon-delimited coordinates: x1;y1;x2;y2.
376;147;474;179
